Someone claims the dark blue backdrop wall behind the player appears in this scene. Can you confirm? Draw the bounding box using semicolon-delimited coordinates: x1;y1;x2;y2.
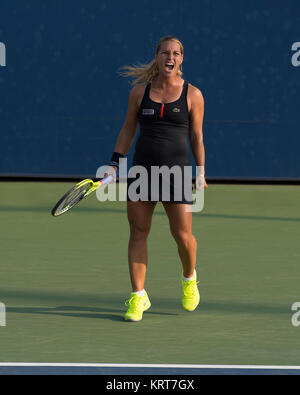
0;0;300;178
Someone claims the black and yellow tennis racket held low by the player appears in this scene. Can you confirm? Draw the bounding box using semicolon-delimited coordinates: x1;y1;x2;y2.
51;175;114;217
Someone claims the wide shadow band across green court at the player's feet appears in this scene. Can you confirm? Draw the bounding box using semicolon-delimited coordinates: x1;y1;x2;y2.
0;288;290;321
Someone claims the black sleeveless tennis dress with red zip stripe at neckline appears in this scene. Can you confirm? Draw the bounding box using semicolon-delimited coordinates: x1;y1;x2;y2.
127;81;193;204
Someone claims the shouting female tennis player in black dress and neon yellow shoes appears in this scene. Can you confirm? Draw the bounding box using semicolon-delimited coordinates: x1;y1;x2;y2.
108;36;207;321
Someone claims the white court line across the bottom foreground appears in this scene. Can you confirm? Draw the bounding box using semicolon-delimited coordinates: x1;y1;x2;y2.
0;362;300;370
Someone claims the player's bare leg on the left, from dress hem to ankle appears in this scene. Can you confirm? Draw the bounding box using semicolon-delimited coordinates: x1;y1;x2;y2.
127;201;156;292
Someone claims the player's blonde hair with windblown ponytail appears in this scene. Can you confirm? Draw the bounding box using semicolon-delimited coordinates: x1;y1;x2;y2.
120;36;183;85
